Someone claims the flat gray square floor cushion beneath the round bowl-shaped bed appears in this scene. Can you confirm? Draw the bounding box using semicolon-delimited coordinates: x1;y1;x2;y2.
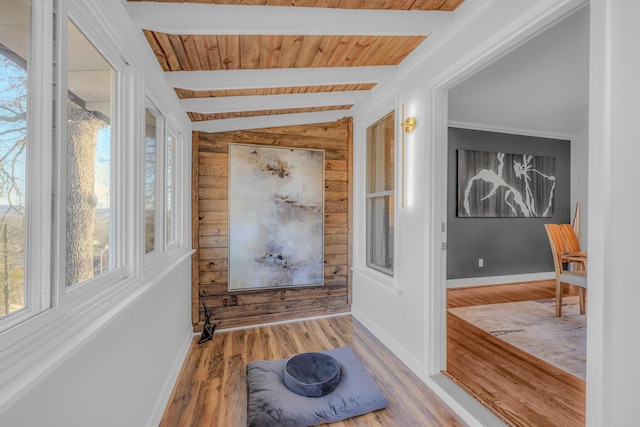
247;347;387;427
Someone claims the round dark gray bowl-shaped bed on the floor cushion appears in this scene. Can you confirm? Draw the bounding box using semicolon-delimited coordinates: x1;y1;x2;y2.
284;353;340;397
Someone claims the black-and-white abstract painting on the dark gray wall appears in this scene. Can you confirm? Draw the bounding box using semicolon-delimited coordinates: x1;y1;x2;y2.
458;150;556;218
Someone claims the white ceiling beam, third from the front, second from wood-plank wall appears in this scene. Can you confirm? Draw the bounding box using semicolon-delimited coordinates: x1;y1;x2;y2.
180;90;369;114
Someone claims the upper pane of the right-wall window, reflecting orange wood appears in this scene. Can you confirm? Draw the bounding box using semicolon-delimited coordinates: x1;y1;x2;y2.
367;113;395;193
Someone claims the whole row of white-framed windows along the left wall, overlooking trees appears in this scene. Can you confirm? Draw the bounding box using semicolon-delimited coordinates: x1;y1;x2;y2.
0;0;182;334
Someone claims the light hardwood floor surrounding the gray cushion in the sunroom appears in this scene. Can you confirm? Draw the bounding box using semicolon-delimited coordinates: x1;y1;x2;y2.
160;315;466;427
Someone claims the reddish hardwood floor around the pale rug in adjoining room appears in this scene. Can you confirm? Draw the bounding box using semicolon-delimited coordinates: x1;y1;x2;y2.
445;281;586;427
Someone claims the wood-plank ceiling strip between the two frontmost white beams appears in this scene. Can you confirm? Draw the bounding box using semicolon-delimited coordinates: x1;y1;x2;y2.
143;30;426;71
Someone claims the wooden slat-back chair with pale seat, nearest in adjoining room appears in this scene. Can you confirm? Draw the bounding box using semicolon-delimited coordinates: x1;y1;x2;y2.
544;224;587;317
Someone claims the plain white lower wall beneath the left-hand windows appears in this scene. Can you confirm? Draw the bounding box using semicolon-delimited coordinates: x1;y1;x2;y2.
0;256;193;427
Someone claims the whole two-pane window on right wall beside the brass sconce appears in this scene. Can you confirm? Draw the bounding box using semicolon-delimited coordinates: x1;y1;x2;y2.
366;112;395;276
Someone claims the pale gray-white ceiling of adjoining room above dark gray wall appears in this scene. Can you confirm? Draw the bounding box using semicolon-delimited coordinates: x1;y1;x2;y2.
449;8;589;136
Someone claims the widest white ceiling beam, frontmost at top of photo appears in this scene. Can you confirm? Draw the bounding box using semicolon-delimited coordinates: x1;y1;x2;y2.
126;2;454;36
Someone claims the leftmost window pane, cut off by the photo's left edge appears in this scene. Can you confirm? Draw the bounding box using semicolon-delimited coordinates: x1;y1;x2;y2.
0;0;30;318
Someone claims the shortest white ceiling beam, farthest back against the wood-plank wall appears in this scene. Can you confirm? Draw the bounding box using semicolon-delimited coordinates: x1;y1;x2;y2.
192;110;350;132
